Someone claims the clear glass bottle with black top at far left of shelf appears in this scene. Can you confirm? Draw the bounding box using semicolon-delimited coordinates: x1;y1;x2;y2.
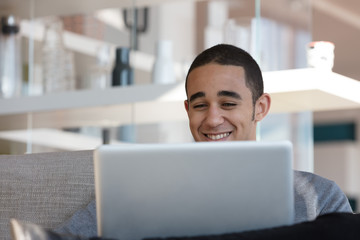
0;16;22;98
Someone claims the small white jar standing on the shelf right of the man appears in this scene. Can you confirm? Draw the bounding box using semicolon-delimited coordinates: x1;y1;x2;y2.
307;41;335;71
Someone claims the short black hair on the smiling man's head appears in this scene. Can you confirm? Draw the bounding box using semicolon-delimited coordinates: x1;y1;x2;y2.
185;44;264;105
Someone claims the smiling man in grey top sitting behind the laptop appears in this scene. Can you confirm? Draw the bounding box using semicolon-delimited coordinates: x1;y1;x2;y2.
184;44;352;223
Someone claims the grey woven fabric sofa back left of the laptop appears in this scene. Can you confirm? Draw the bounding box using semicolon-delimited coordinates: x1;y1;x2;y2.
0;150;95;239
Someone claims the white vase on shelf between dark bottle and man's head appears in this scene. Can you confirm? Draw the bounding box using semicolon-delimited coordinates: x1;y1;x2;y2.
152;40;176;84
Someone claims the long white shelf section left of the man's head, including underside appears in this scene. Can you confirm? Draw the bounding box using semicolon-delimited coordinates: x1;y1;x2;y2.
0;83;186;131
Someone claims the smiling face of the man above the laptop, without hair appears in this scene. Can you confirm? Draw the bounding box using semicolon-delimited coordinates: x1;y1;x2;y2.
185;63;257;142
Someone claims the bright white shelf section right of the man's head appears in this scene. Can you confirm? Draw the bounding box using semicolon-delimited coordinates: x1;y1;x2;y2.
263;68;360;112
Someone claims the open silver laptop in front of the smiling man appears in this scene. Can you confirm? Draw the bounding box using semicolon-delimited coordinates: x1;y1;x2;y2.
94;141;294;240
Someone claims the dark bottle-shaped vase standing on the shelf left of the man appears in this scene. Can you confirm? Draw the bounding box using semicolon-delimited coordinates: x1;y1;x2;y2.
111;47;134;86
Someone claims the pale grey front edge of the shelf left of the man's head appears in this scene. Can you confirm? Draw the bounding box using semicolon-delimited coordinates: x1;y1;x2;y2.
0;83;185;115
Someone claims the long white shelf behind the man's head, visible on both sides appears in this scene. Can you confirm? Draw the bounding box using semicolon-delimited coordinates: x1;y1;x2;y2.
0;69;360;131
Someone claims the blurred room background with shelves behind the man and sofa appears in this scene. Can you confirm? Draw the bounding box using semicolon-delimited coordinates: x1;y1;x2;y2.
0;0;360;209
